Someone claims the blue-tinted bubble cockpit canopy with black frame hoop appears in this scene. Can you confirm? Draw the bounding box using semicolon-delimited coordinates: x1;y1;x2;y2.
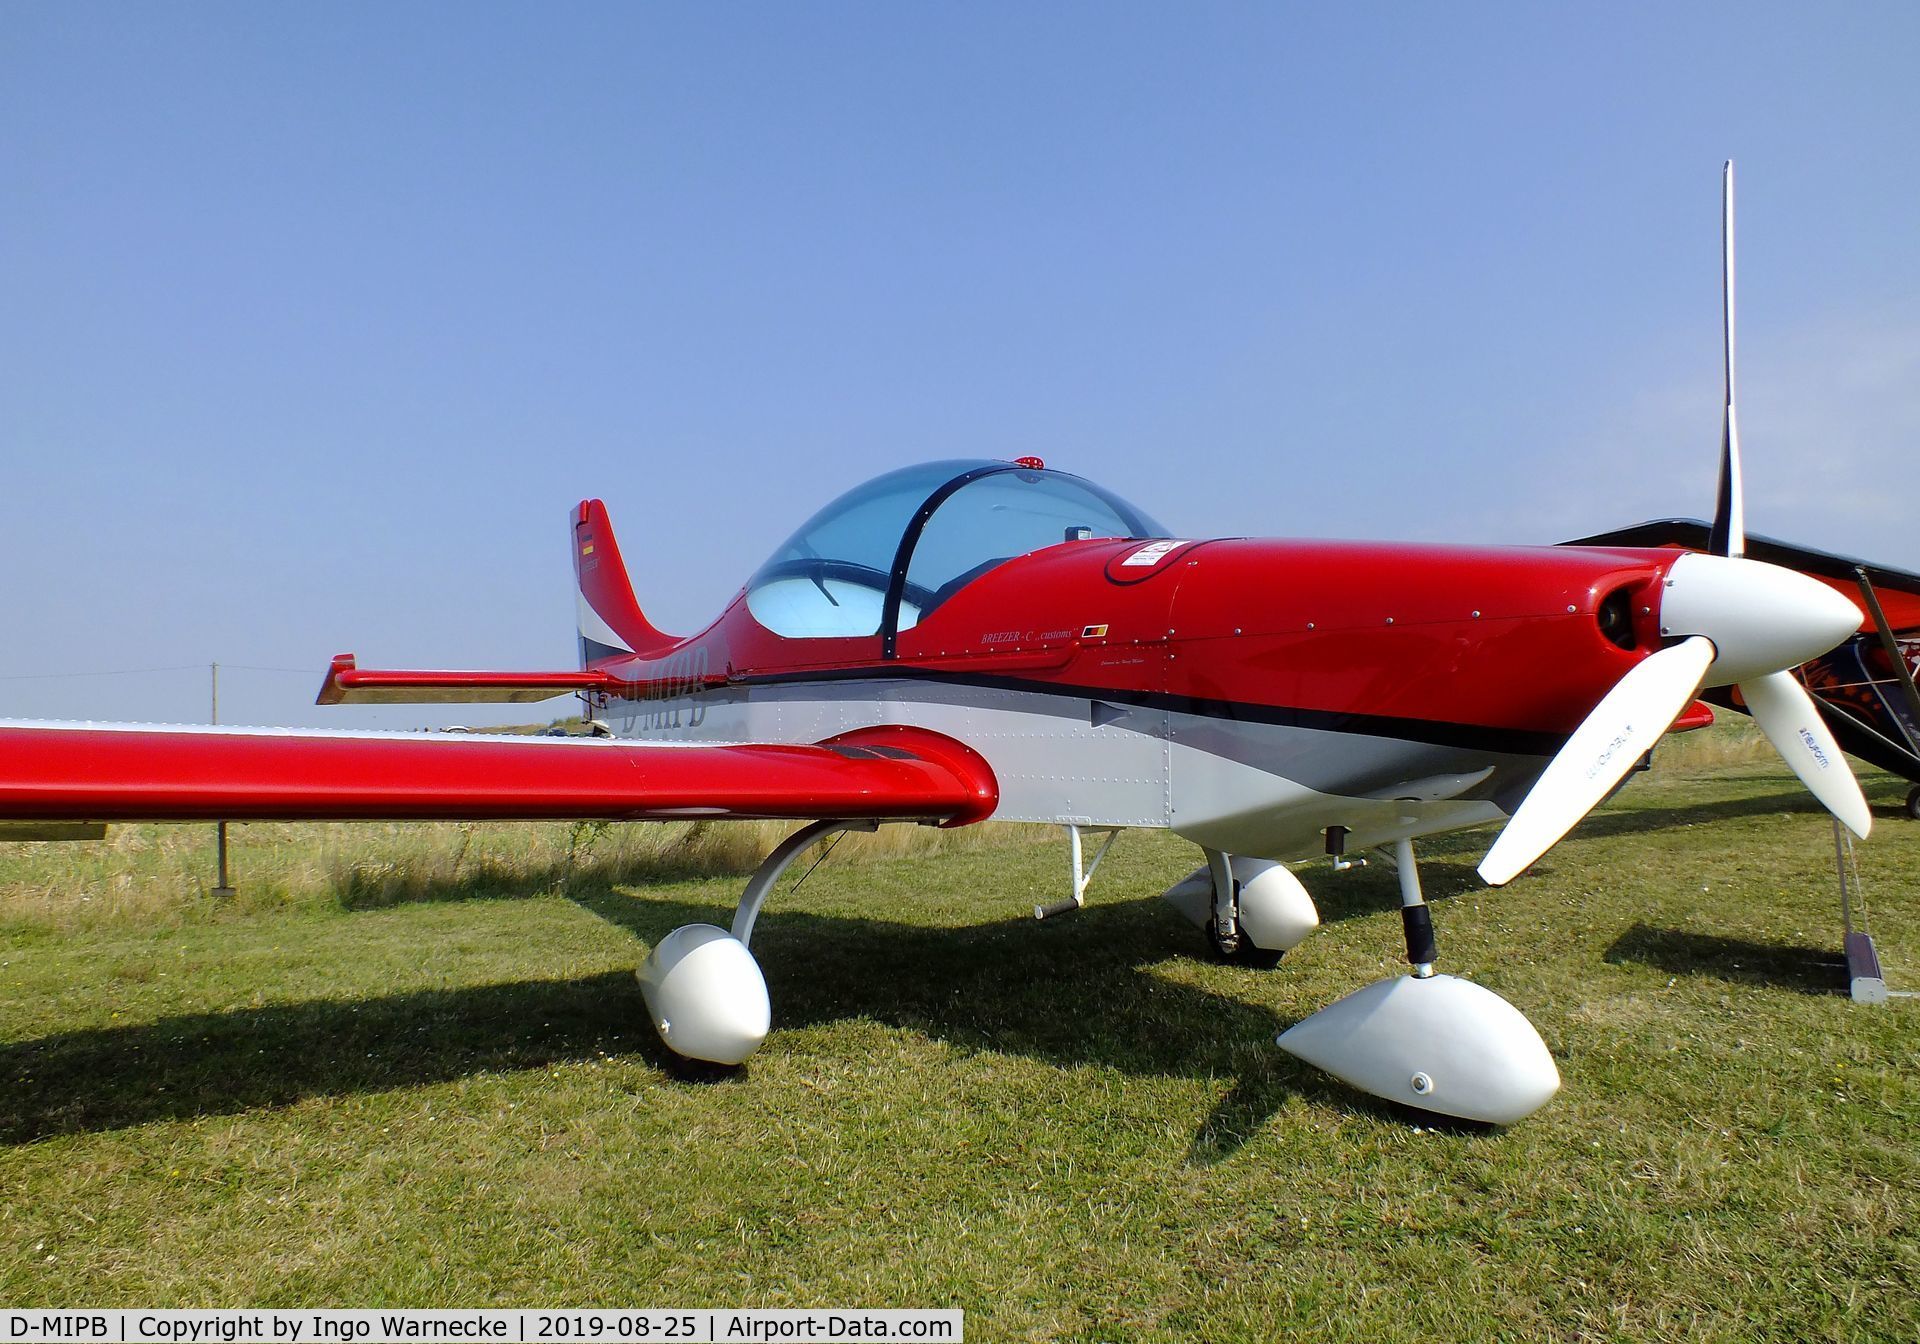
747;459;1167;645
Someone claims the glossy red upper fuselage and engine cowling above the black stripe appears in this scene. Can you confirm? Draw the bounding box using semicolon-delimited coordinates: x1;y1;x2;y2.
599;540;1674;755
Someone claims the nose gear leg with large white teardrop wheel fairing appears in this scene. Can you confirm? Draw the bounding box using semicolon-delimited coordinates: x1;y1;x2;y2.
1279;839;1559;1125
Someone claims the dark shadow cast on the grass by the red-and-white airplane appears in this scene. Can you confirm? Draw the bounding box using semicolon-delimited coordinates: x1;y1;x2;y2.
0;864;1476;1164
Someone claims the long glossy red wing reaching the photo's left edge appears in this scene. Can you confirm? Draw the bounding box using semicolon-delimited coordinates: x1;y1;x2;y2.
0;720;998;826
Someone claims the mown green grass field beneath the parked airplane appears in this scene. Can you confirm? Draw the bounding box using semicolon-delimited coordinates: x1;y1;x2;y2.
0;732;1920;1340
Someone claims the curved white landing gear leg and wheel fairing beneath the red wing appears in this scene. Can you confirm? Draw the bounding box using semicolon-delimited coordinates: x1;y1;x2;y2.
639;822;879;1064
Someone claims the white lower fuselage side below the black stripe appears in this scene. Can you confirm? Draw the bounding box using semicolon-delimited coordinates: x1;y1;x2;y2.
597;678;1546;858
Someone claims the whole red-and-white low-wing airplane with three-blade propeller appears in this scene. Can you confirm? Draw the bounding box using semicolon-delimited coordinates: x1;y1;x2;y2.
0;169;1870;1123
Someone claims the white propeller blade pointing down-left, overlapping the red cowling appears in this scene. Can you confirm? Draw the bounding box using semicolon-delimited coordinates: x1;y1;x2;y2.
1480;636;1713;887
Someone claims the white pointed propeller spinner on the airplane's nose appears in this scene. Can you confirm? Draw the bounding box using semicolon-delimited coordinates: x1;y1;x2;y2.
1661;555;1860;685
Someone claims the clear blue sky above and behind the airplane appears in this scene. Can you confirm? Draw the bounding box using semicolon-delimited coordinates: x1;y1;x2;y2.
0;4;1920;726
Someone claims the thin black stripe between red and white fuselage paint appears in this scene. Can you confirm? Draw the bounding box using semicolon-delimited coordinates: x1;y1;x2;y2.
732;664;1567;756
